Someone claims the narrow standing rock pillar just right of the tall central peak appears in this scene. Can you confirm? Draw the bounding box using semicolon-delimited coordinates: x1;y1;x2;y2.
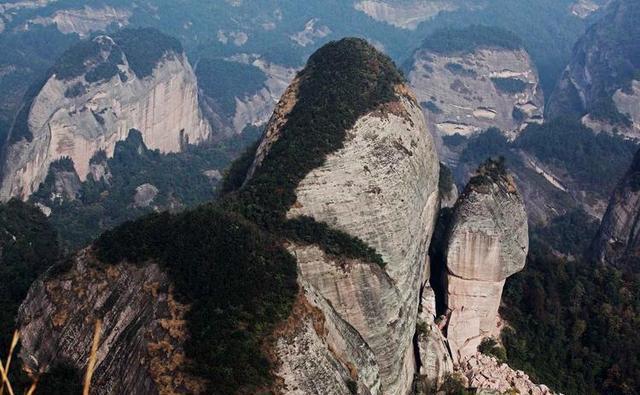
446;168;529;363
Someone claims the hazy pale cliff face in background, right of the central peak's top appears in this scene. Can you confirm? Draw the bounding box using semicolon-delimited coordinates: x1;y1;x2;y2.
409;48;544;143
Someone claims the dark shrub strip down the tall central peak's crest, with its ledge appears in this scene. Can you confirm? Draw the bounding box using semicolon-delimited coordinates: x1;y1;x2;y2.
223;38;403;263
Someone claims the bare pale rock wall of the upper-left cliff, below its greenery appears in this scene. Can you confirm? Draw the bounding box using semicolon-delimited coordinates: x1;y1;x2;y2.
0;36;211;200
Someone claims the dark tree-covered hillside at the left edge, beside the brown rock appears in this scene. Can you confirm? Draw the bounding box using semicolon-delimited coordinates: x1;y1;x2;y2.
0;200;59;350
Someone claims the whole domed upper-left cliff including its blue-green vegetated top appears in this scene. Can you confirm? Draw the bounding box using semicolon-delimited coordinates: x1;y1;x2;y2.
0;29;211;200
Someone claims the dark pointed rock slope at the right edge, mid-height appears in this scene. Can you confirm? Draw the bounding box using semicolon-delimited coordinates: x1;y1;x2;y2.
592;153;640;265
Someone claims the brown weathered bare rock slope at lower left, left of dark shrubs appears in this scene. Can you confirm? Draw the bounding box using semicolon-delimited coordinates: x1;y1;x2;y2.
18;250;205;394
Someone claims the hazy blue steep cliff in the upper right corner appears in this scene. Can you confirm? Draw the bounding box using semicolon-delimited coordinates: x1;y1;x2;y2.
548;0;640;139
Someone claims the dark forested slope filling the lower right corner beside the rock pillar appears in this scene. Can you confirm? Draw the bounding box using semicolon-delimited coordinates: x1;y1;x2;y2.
501;235;640;395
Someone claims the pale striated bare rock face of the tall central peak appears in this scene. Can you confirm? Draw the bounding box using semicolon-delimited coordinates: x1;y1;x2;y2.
280;92;439;394
